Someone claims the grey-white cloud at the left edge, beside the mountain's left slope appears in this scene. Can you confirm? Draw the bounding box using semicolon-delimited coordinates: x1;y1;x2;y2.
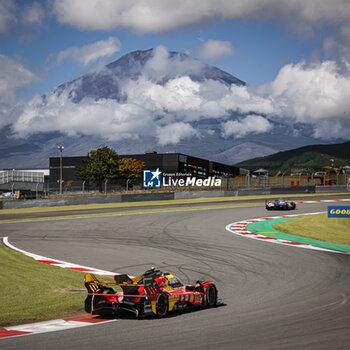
0;54;36;127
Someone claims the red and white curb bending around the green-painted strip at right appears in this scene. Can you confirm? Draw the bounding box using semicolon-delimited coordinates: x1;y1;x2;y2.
226;212;346;254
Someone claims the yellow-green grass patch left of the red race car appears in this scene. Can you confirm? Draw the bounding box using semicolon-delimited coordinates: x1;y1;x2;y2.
0;244;90;327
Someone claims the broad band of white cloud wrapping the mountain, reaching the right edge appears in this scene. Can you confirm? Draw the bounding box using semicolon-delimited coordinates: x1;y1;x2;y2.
7;46;350;145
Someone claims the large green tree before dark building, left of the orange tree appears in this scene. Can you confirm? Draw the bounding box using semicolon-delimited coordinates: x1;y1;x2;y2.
77;146;120;192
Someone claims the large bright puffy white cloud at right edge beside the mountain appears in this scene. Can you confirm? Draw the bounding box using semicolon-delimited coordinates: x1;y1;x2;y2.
266;61;350;138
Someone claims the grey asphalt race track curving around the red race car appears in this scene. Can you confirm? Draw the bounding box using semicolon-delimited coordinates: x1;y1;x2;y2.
0;196;350;350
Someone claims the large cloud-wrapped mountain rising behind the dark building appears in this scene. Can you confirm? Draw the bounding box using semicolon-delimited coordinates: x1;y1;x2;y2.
0;48;344;169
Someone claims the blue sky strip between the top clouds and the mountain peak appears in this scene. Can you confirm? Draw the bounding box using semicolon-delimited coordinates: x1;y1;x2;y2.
1;17;322;96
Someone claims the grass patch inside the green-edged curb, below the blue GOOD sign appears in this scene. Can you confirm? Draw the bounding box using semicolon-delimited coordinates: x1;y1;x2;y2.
273;213;350;246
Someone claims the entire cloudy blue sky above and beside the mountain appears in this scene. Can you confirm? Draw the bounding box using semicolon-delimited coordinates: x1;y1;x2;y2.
0;0;350;144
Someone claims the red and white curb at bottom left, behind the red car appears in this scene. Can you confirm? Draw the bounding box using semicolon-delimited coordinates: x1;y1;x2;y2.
0;315;117;339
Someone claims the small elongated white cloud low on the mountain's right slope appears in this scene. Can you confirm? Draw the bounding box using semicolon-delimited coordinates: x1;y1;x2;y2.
222;115;273;138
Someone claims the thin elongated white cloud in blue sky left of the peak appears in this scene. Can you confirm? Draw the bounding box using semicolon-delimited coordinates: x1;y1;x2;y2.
49;37;121;66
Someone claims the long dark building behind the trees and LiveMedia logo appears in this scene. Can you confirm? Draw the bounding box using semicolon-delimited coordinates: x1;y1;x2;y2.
50;152;240;191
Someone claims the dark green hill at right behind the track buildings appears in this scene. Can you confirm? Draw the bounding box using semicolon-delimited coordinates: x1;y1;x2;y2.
234;141;350;174
